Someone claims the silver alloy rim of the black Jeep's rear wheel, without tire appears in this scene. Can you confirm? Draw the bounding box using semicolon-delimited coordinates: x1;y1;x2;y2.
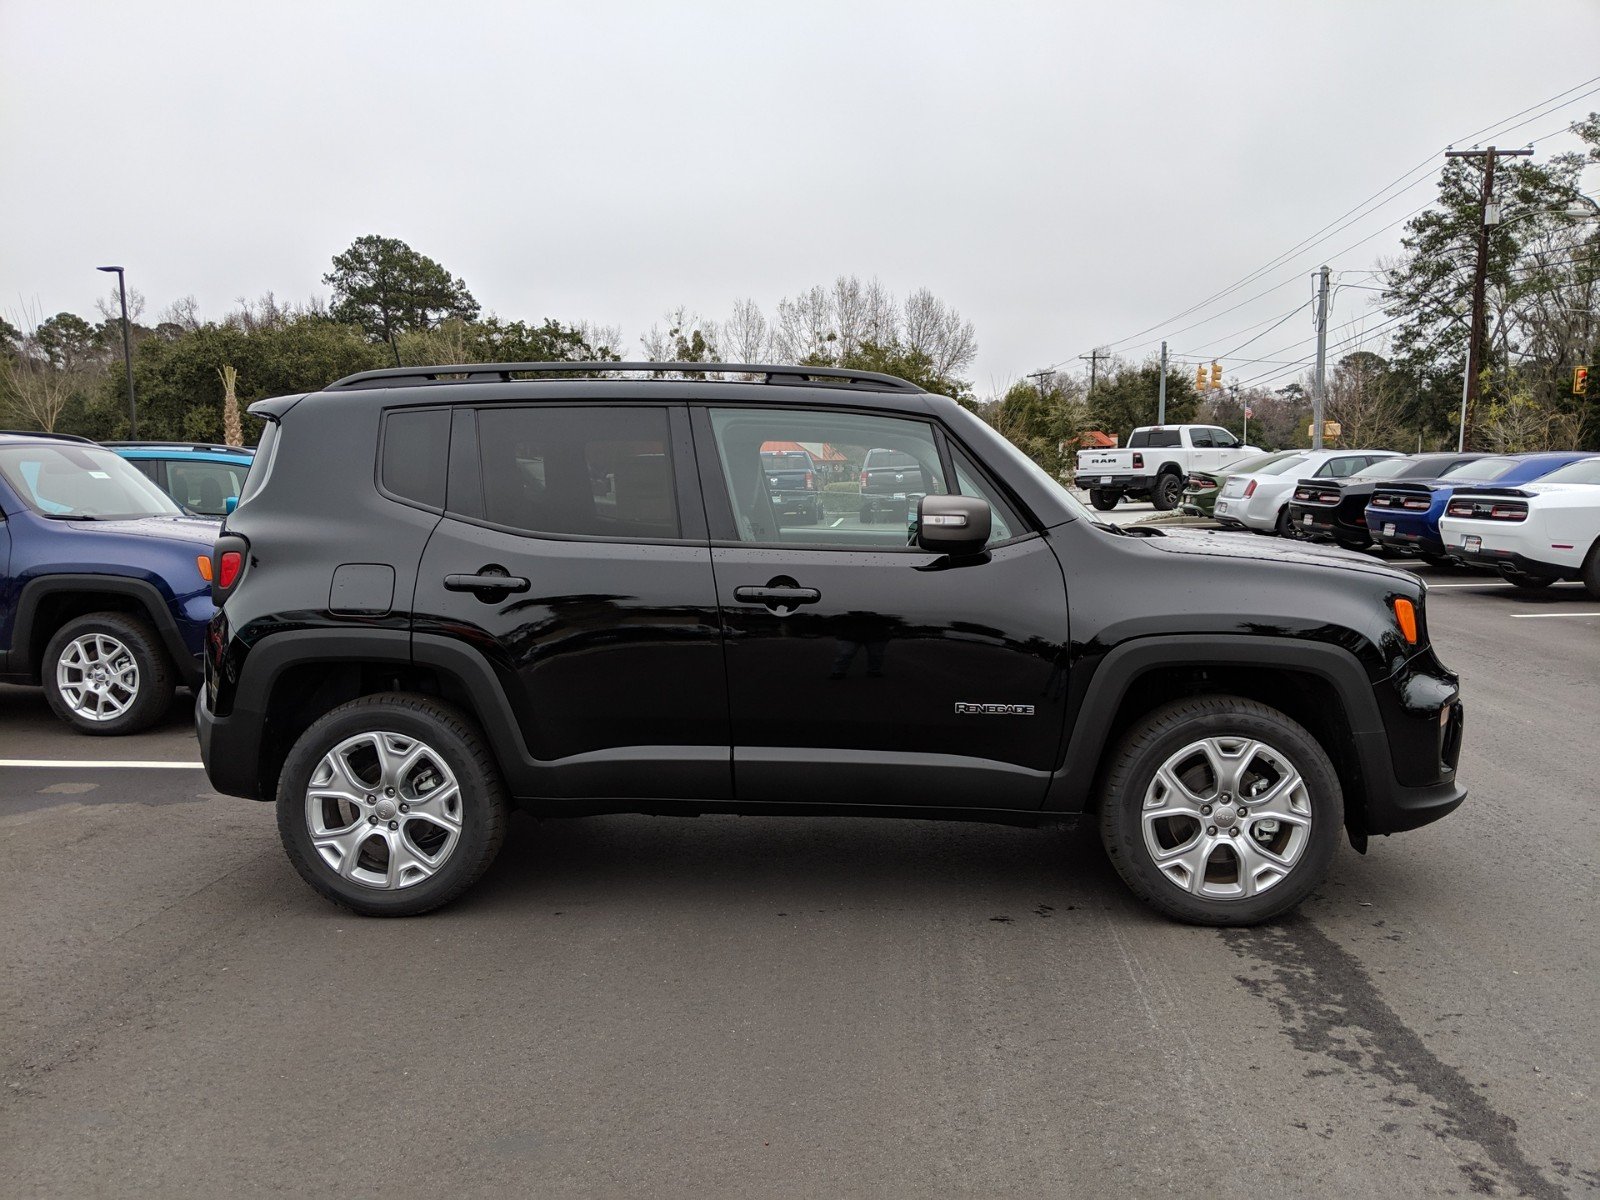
306;730;462;891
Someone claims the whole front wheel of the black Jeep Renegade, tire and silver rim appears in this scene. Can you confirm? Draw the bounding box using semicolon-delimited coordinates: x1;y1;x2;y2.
1099;696;1344;925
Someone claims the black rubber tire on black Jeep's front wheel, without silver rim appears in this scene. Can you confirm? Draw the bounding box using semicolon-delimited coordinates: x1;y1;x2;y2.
1099;696;1344;925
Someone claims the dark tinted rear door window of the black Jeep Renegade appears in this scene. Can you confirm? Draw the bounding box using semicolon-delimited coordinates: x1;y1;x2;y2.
478;405;680;538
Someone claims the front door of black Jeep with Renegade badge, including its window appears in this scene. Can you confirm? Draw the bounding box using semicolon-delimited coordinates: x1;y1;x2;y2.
694;405;1067;810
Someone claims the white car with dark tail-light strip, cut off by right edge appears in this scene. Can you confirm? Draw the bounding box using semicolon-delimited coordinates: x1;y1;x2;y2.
1438;458;1600;600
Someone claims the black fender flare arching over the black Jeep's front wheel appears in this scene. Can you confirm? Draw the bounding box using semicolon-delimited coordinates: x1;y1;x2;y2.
1043;634;1392;813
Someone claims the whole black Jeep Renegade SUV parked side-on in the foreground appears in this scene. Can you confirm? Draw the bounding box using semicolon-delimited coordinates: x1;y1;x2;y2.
197;363;1464;925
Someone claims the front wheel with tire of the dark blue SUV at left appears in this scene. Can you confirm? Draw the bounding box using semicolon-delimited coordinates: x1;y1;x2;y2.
40;613;174;738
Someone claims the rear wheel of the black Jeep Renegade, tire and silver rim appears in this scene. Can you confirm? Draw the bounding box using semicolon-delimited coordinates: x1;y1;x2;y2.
278;693;509;917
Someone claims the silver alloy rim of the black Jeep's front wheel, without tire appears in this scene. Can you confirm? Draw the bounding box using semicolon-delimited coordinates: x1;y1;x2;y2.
1139;738;1312;901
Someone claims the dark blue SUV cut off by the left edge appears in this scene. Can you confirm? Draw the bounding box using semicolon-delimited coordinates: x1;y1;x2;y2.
0;432;216;734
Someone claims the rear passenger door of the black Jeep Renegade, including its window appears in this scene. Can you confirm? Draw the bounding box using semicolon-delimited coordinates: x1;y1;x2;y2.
413;403;731;800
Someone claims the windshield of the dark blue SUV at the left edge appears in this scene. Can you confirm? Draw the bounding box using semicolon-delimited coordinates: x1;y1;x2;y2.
0;442;182;520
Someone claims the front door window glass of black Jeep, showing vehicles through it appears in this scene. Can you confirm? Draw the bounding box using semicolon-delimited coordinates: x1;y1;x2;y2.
710;408;940;550
